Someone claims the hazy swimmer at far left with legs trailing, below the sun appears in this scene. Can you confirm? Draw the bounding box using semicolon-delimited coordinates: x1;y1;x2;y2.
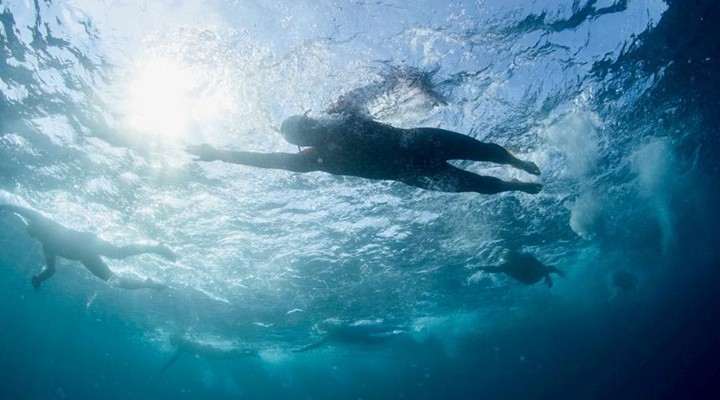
0;204;177;290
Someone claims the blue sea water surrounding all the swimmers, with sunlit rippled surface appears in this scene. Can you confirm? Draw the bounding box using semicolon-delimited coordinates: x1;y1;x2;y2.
0;0;720;399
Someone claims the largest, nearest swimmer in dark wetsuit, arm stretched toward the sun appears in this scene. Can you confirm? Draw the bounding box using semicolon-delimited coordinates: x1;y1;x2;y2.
188;113;542;194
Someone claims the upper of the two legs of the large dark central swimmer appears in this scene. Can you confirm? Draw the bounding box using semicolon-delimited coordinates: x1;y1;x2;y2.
416;128;540;175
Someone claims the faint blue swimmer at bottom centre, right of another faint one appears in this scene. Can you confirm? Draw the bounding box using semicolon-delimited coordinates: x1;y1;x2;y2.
293;319;410;353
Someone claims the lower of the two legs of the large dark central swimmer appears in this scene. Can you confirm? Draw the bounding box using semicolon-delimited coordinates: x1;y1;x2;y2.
403;164;542;194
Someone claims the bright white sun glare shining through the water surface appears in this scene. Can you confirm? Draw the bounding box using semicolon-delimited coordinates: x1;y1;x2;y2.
127;59;230;138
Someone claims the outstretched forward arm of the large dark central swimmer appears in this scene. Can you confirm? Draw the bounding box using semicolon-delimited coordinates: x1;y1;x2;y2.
187;144;318;172
